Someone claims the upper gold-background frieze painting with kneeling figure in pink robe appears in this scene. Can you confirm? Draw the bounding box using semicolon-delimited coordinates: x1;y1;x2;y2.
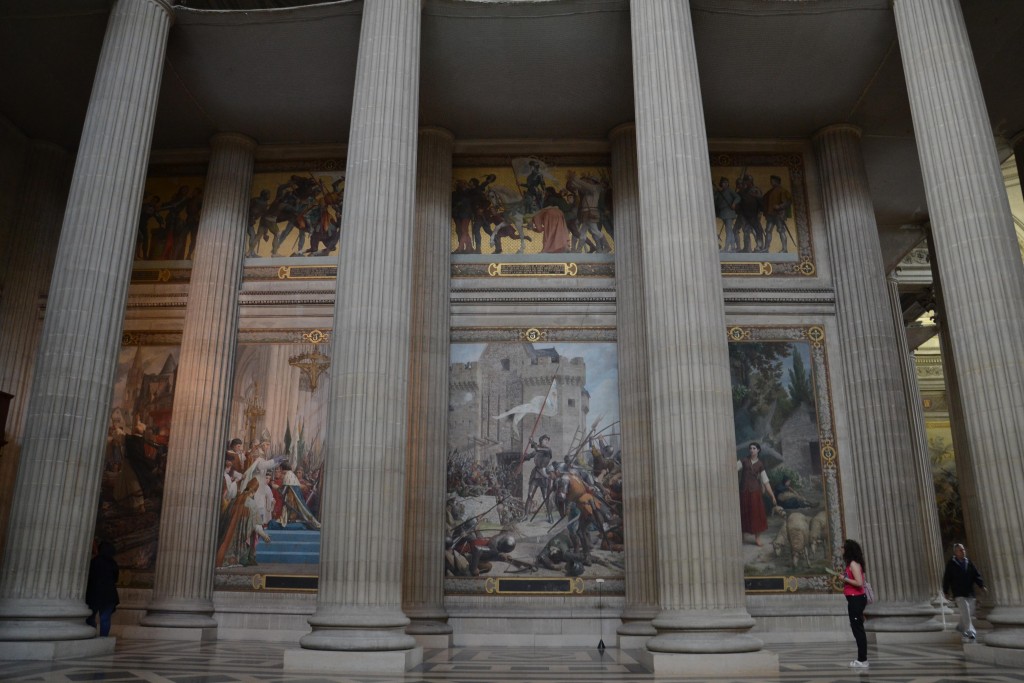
452;157;614;260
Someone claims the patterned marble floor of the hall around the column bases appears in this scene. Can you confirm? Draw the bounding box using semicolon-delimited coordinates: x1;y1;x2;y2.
0;640;1024;683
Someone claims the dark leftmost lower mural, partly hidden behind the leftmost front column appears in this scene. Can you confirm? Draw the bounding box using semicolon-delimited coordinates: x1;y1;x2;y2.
95;345;178;585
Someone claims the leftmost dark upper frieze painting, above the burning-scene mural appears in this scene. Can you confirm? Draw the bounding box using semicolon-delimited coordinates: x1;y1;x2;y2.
135;175;205;261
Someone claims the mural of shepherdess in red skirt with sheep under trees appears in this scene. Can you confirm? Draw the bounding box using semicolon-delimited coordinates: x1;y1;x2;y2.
729;326;844;592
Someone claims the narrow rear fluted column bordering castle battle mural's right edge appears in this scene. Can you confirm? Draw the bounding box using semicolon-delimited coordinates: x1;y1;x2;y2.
609;123;658;649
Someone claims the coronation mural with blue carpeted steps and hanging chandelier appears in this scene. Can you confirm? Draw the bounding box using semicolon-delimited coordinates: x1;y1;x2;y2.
215;331;331;589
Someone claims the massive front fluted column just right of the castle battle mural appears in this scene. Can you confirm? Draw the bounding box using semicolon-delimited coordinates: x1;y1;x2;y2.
630;0;778;675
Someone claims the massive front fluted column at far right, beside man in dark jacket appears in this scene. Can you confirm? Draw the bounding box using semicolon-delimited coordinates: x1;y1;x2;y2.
893;0;1024;665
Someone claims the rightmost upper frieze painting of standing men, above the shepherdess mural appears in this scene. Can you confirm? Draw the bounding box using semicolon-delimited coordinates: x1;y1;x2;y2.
711;153;816;276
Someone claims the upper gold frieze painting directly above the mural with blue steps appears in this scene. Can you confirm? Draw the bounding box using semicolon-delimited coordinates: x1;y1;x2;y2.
246;171;345;258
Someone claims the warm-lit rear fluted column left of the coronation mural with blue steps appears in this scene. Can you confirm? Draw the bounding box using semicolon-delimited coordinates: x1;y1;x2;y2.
134;133;256;640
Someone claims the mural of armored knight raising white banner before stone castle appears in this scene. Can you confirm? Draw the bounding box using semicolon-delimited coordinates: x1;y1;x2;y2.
444;342;629;593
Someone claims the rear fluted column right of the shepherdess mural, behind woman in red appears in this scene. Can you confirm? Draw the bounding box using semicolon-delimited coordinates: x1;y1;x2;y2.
813;125;937;631
